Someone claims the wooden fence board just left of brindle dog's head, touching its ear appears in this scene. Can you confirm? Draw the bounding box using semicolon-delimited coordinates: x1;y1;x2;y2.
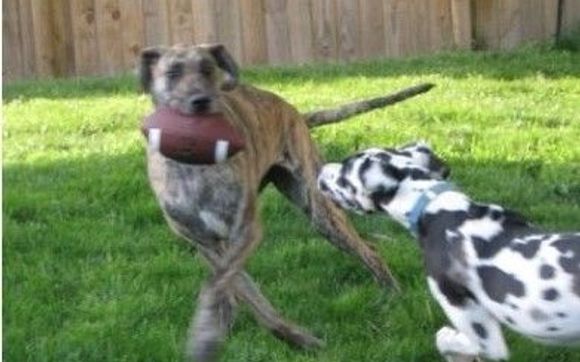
119;0;145;70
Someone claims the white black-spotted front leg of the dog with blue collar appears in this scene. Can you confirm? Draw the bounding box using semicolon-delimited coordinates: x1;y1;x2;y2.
427;278;509;362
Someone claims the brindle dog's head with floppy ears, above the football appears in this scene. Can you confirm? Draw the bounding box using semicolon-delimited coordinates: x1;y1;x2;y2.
139;44;238;114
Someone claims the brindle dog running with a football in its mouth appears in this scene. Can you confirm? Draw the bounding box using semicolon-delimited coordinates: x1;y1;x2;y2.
139;45;431;361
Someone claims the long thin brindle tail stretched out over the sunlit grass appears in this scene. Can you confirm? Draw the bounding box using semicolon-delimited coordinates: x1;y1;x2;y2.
304;83;435;128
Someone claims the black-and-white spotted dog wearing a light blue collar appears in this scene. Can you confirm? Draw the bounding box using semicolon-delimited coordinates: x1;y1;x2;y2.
318;144;580;362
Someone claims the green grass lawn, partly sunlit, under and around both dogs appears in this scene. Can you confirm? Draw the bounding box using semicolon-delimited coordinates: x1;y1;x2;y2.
3;43;580;362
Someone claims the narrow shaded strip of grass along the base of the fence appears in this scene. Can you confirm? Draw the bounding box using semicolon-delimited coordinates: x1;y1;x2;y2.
3;46;580;103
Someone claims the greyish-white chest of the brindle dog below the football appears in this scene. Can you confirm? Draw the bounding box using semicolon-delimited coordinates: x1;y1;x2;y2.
148;152;243;244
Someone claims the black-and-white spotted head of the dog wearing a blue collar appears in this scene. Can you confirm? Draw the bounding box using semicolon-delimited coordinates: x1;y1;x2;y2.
318;142;449;213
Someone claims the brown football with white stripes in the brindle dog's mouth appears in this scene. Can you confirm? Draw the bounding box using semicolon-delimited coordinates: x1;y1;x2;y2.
141;108;244;165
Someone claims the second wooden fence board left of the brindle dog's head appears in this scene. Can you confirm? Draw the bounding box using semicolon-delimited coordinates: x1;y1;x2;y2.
95;0;123;75
